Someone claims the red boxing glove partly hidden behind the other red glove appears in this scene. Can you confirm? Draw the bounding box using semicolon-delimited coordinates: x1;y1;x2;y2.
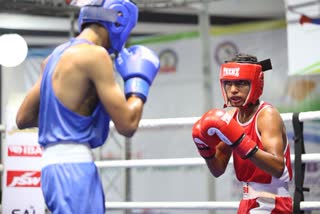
192;118;220;159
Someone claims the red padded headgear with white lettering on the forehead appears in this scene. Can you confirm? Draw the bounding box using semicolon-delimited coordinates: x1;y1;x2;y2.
220;62;263;107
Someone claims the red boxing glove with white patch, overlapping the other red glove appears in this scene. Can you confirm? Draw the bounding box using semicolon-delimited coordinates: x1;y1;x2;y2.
201;109;258;159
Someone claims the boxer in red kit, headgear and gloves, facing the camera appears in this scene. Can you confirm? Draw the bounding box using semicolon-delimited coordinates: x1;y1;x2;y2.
192;54;293;214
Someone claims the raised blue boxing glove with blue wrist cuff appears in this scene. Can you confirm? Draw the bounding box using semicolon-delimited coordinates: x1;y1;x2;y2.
115;45;160;102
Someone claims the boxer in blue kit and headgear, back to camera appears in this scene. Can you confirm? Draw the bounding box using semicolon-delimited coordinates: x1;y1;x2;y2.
16;0;159;214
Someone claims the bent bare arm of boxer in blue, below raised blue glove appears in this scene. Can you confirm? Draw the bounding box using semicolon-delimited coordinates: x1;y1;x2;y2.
86;48;143;137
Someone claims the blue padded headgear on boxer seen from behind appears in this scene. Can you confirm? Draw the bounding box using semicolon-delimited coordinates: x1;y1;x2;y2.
78;0;139;53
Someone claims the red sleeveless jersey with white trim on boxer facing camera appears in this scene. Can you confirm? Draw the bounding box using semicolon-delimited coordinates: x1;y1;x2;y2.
233;102;292;184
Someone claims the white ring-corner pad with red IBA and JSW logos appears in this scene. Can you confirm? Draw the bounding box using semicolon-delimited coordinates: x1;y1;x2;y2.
2;100;45;214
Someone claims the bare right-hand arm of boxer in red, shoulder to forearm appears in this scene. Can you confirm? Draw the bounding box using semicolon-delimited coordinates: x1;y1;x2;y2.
250;107;287;177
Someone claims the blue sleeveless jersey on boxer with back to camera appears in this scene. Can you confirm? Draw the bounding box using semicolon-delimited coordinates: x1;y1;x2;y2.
38;39;110;148
